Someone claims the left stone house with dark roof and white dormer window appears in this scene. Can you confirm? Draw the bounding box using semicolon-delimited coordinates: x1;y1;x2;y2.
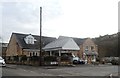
6;33;56;65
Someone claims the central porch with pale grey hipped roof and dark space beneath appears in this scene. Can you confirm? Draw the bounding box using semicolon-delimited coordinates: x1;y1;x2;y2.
43;37;80;65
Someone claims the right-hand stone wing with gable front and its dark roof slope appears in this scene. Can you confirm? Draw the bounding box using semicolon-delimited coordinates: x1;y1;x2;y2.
73;38;98;63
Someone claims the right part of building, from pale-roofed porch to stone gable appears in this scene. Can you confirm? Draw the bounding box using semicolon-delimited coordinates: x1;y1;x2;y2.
44;36;98;63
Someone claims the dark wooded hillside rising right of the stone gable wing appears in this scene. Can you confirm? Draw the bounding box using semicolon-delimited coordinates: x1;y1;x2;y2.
93;33;119;57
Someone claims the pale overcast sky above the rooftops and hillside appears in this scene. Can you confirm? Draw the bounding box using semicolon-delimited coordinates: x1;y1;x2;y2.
0;0;119;42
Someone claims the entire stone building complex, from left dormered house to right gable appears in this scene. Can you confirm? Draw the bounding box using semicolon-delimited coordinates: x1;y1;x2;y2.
6;33;98;63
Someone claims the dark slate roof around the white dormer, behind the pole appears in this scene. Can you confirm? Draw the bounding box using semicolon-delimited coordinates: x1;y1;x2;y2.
12;33;56;49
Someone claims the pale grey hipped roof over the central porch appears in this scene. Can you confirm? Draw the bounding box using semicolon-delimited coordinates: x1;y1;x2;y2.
43;36;79;50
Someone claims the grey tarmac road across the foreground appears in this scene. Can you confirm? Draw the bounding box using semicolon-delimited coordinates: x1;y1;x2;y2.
2;65;118;78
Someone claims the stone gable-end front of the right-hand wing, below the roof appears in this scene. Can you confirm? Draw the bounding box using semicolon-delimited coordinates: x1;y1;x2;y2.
79;38;98;63
